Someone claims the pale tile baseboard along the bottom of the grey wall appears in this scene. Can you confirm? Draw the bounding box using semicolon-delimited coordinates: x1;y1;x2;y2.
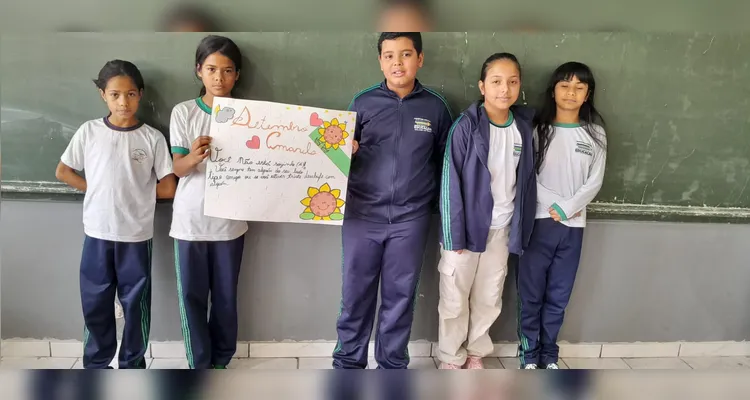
0;339;750;359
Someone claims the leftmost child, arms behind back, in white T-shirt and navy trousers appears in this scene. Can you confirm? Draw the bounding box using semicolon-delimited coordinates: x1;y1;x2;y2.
55;60;175;369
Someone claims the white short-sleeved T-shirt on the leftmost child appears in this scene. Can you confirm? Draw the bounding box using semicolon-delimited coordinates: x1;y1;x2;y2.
60;117;172;242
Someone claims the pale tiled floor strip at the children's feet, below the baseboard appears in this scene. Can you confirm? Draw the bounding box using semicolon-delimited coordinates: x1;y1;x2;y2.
0;357;750;370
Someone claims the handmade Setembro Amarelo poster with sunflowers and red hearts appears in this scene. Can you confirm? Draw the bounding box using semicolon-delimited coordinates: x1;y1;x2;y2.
204;97;356;225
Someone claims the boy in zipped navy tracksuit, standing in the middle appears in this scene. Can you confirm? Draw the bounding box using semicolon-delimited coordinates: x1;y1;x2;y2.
333;32;452;369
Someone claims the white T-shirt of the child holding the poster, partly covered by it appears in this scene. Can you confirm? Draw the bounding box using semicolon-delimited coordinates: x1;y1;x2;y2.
169;98;247;241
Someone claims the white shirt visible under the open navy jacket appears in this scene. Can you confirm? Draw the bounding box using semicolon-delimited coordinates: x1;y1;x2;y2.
487;112;522;229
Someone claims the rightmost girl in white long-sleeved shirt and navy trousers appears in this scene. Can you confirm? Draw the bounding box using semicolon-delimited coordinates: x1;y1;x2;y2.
518;62;607;369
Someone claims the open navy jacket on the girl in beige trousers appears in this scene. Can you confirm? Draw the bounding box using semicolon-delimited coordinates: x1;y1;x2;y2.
440;103;536;255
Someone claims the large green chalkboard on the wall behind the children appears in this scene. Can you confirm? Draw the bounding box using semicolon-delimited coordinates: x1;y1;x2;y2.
0;33;750;219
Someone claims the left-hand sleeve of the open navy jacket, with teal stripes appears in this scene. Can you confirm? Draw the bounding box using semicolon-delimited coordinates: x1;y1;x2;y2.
440;115;471;251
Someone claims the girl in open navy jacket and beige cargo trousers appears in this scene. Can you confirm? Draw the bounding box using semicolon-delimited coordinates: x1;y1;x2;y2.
438;53;536;369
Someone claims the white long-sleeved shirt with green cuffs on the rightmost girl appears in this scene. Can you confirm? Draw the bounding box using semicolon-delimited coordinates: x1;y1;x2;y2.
536;124;607;228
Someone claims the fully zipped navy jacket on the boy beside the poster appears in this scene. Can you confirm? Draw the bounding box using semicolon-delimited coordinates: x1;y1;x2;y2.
346;81;453;224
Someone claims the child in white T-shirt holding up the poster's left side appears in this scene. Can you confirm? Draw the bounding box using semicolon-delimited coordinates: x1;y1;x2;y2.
170;36;248;369
